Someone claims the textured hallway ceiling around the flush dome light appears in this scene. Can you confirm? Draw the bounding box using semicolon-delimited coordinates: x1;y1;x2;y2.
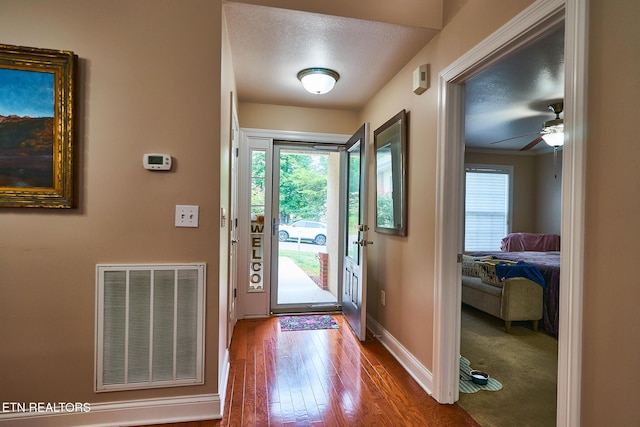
224;2;438;110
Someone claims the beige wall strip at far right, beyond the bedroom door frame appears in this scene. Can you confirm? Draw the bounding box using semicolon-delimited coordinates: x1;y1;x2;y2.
584;0;640;427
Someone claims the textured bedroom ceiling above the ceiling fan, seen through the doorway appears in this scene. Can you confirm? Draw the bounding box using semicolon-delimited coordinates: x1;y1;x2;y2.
465;28;564;150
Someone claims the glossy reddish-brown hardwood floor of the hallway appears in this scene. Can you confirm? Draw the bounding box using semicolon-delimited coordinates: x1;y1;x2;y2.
142;315;478;427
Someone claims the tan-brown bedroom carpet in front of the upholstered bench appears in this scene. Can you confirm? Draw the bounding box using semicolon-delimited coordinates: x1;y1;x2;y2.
458;305;558;427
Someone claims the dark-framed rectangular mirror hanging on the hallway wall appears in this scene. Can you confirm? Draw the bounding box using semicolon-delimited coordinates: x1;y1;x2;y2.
373;110;408;236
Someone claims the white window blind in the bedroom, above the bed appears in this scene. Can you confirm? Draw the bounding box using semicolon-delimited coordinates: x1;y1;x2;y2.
464;165;513;251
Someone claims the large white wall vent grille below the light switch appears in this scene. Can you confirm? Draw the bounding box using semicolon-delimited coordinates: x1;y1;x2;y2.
96;264;205;391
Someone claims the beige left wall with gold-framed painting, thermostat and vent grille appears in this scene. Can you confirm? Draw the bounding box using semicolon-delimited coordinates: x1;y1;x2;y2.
0;0;221;402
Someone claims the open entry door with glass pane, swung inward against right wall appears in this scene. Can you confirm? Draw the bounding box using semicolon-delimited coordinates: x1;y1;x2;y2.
342;123;373;341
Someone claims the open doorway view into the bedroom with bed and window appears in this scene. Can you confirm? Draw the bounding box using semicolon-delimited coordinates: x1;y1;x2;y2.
458;26;564;425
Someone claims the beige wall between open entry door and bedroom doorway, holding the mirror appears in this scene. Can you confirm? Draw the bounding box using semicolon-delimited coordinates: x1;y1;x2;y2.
360;0;532;369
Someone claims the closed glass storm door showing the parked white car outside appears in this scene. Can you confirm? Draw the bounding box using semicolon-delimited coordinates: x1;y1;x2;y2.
271;145;340;312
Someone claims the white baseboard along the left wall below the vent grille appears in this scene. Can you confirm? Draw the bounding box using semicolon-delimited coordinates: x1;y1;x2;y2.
0;394;222;427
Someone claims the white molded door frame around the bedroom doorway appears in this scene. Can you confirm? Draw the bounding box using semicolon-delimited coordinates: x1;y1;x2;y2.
433;0;588;426
